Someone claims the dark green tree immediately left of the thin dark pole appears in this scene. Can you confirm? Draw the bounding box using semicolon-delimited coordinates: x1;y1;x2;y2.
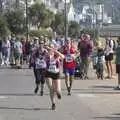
5;9;25;34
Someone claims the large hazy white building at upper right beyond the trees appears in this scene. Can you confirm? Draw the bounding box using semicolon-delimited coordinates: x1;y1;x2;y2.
74;0;112;27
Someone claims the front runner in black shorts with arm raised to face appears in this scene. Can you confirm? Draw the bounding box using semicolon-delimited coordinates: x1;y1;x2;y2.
46;44;64;110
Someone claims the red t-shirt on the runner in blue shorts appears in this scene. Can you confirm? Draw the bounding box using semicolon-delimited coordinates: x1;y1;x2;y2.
63;47;76;69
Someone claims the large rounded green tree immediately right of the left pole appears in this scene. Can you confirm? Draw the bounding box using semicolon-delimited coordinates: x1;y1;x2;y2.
29;3;53;29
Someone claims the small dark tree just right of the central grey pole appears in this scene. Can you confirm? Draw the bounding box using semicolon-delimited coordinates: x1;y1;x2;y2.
68;21;80;37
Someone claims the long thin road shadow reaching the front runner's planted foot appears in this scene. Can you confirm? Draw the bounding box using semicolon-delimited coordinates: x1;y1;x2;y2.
0;107;51;111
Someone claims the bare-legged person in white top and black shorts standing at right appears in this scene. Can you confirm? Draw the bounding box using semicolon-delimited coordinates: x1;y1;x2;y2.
105;38;114;79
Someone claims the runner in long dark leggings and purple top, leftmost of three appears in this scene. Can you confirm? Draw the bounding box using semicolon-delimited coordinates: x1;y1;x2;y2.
31;41;47;96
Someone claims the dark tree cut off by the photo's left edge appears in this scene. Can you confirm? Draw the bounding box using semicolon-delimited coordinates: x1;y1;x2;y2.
0;16;9;37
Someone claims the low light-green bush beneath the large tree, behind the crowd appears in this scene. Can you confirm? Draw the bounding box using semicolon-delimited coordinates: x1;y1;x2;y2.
30;29;52;37
